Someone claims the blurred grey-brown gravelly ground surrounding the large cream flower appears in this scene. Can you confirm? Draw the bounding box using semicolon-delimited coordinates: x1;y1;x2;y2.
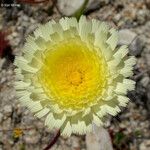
0;0;150;150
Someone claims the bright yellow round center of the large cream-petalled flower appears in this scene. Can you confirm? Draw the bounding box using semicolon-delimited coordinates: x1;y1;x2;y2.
38;38;107;110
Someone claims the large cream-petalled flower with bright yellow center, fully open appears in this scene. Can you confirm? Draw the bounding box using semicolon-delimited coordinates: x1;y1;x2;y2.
15;16;136;136
